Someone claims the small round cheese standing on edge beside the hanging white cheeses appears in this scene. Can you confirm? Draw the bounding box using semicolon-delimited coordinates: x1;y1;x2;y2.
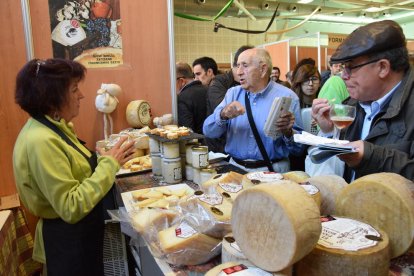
126;100;151;128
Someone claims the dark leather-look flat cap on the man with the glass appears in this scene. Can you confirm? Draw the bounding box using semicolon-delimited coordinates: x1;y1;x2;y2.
331;20;406;63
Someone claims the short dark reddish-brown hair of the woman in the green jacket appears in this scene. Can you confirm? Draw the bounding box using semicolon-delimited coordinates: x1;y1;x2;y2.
15;58;86;117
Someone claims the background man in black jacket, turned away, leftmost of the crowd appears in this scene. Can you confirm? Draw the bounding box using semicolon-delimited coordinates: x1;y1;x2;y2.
175;62;207;136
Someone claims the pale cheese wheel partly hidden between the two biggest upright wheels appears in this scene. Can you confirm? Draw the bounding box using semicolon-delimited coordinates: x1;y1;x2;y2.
306;175;348;215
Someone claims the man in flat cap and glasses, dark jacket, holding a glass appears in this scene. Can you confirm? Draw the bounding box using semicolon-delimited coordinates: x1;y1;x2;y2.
312;20;414;181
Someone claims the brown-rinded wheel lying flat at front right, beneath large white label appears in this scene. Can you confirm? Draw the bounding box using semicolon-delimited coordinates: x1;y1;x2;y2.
295;219;390;276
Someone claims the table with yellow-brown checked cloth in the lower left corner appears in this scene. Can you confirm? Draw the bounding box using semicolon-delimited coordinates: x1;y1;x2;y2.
0;208;42;275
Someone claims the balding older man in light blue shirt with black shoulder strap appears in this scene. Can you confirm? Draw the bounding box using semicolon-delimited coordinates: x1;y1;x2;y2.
203;48;304;172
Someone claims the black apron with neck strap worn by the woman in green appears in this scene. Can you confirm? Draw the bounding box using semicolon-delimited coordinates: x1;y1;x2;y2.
35;116;104;276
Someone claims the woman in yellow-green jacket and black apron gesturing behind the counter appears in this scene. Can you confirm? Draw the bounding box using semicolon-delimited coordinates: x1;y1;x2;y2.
13;59;134;276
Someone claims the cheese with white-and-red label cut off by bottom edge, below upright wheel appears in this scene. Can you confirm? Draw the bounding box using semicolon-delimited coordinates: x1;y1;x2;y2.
205;261;292;276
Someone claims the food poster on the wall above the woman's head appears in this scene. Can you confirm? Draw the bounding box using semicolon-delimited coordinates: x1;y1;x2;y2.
49;0;123;68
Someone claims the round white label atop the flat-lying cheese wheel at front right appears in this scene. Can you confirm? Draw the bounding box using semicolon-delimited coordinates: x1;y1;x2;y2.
318;218;380;251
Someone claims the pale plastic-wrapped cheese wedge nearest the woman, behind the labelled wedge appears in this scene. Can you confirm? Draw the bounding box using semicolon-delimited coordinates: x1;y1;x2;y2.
131;208;177;233
